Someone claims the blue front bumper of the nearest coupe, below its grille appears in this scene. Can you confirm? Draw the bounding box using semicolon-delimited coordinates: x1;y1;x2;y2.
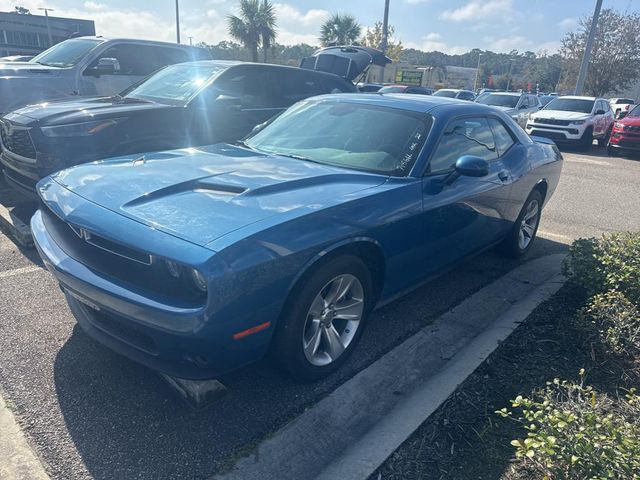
31;210;268;379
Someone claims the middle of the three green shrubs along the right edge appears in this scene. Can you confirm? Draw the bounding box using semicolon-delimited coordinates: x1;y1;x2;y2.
578;290;640;355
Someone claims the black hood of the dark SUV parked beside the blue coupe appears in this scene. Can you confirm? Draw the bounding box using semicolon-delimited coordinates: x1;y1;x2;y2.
6;97;172;126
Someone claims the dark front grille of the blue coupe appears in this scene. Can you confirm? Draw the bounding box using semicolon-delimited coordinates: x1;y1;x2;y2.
40;202;206;308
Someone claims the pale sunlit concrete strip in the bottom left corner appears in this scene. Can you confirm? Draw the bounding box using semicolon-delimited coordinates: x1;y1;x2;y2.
0;396;49;480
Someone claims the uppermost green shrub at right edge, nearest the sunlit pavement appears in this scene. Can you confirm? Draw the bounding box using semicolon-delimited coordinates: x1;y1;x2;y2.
563;232;640;305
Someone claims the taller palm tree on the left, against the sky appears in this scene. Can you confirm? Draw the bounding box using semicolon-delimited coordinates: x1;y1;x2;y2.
227;0;276;62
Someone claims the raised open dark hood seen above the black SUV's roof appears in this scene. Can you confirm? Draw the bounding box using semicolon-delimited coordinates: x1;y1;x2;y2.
300;45;392;81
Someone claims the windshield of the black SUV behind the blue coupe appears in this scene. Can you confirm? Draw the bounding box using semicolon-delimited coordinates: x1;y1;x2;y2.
124;64;228;105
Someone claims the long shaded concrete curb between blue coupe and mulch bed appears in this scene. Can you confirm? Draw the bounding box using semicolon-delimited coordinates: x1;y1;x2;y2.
215;254;565;480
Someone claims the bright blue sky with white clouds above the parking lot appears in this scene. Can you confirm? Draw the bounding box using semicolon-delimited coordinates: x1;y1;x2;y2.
0;0;640;53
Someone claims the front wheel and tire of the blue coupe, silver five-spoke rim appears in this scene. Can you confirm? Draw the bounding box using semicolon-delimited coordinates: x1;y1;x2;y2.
272;255;373;382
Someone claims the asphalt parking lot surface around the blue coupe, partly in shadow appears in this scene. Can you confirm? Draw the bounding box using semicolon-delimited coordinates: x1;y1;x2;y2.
0;146;640;478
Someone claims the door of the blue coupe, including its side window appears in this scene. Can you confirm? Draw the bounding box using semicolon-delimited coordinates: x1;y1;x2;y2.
423;116;513;270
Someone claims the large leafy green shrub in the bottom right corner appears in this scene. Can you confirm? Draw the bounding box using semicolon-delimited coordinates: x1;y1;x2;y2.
496;371;640;480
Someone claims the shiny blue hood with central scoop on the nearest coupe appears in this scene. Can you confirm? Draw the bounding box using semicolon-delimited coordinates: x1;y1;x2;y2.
48;144;387;246
